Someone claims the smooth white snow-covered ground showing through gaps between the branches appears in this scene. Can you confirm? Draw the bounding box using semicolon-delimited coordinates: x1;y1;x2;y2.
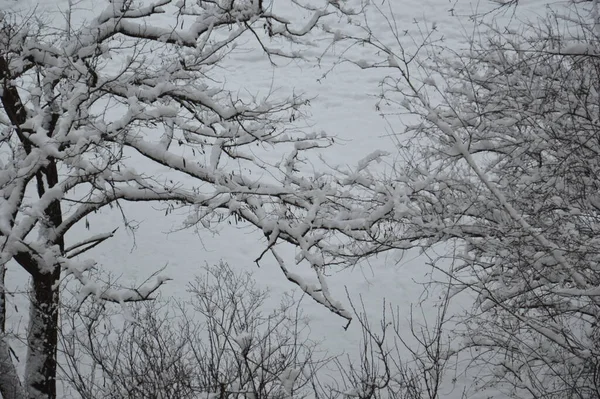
0;0;547;399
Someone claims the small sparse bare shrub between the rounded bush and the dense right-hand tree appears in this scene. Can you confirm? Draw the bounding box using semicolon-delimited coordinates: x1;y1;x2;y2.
317;287;465;399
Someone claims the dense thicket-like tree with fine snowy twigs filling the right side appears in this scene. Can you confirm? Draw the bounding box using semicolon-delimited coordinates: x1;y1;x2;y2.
332;1;600;398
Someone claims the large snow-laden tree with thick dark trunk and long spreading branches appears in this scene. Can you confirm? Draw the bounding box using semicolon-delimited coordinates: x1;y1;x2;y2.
0;0;389;399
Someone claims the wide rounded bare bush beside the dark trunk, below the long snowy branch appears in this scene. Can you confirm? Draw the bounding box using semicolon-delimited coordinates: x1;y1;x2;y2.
60;263;327;399
